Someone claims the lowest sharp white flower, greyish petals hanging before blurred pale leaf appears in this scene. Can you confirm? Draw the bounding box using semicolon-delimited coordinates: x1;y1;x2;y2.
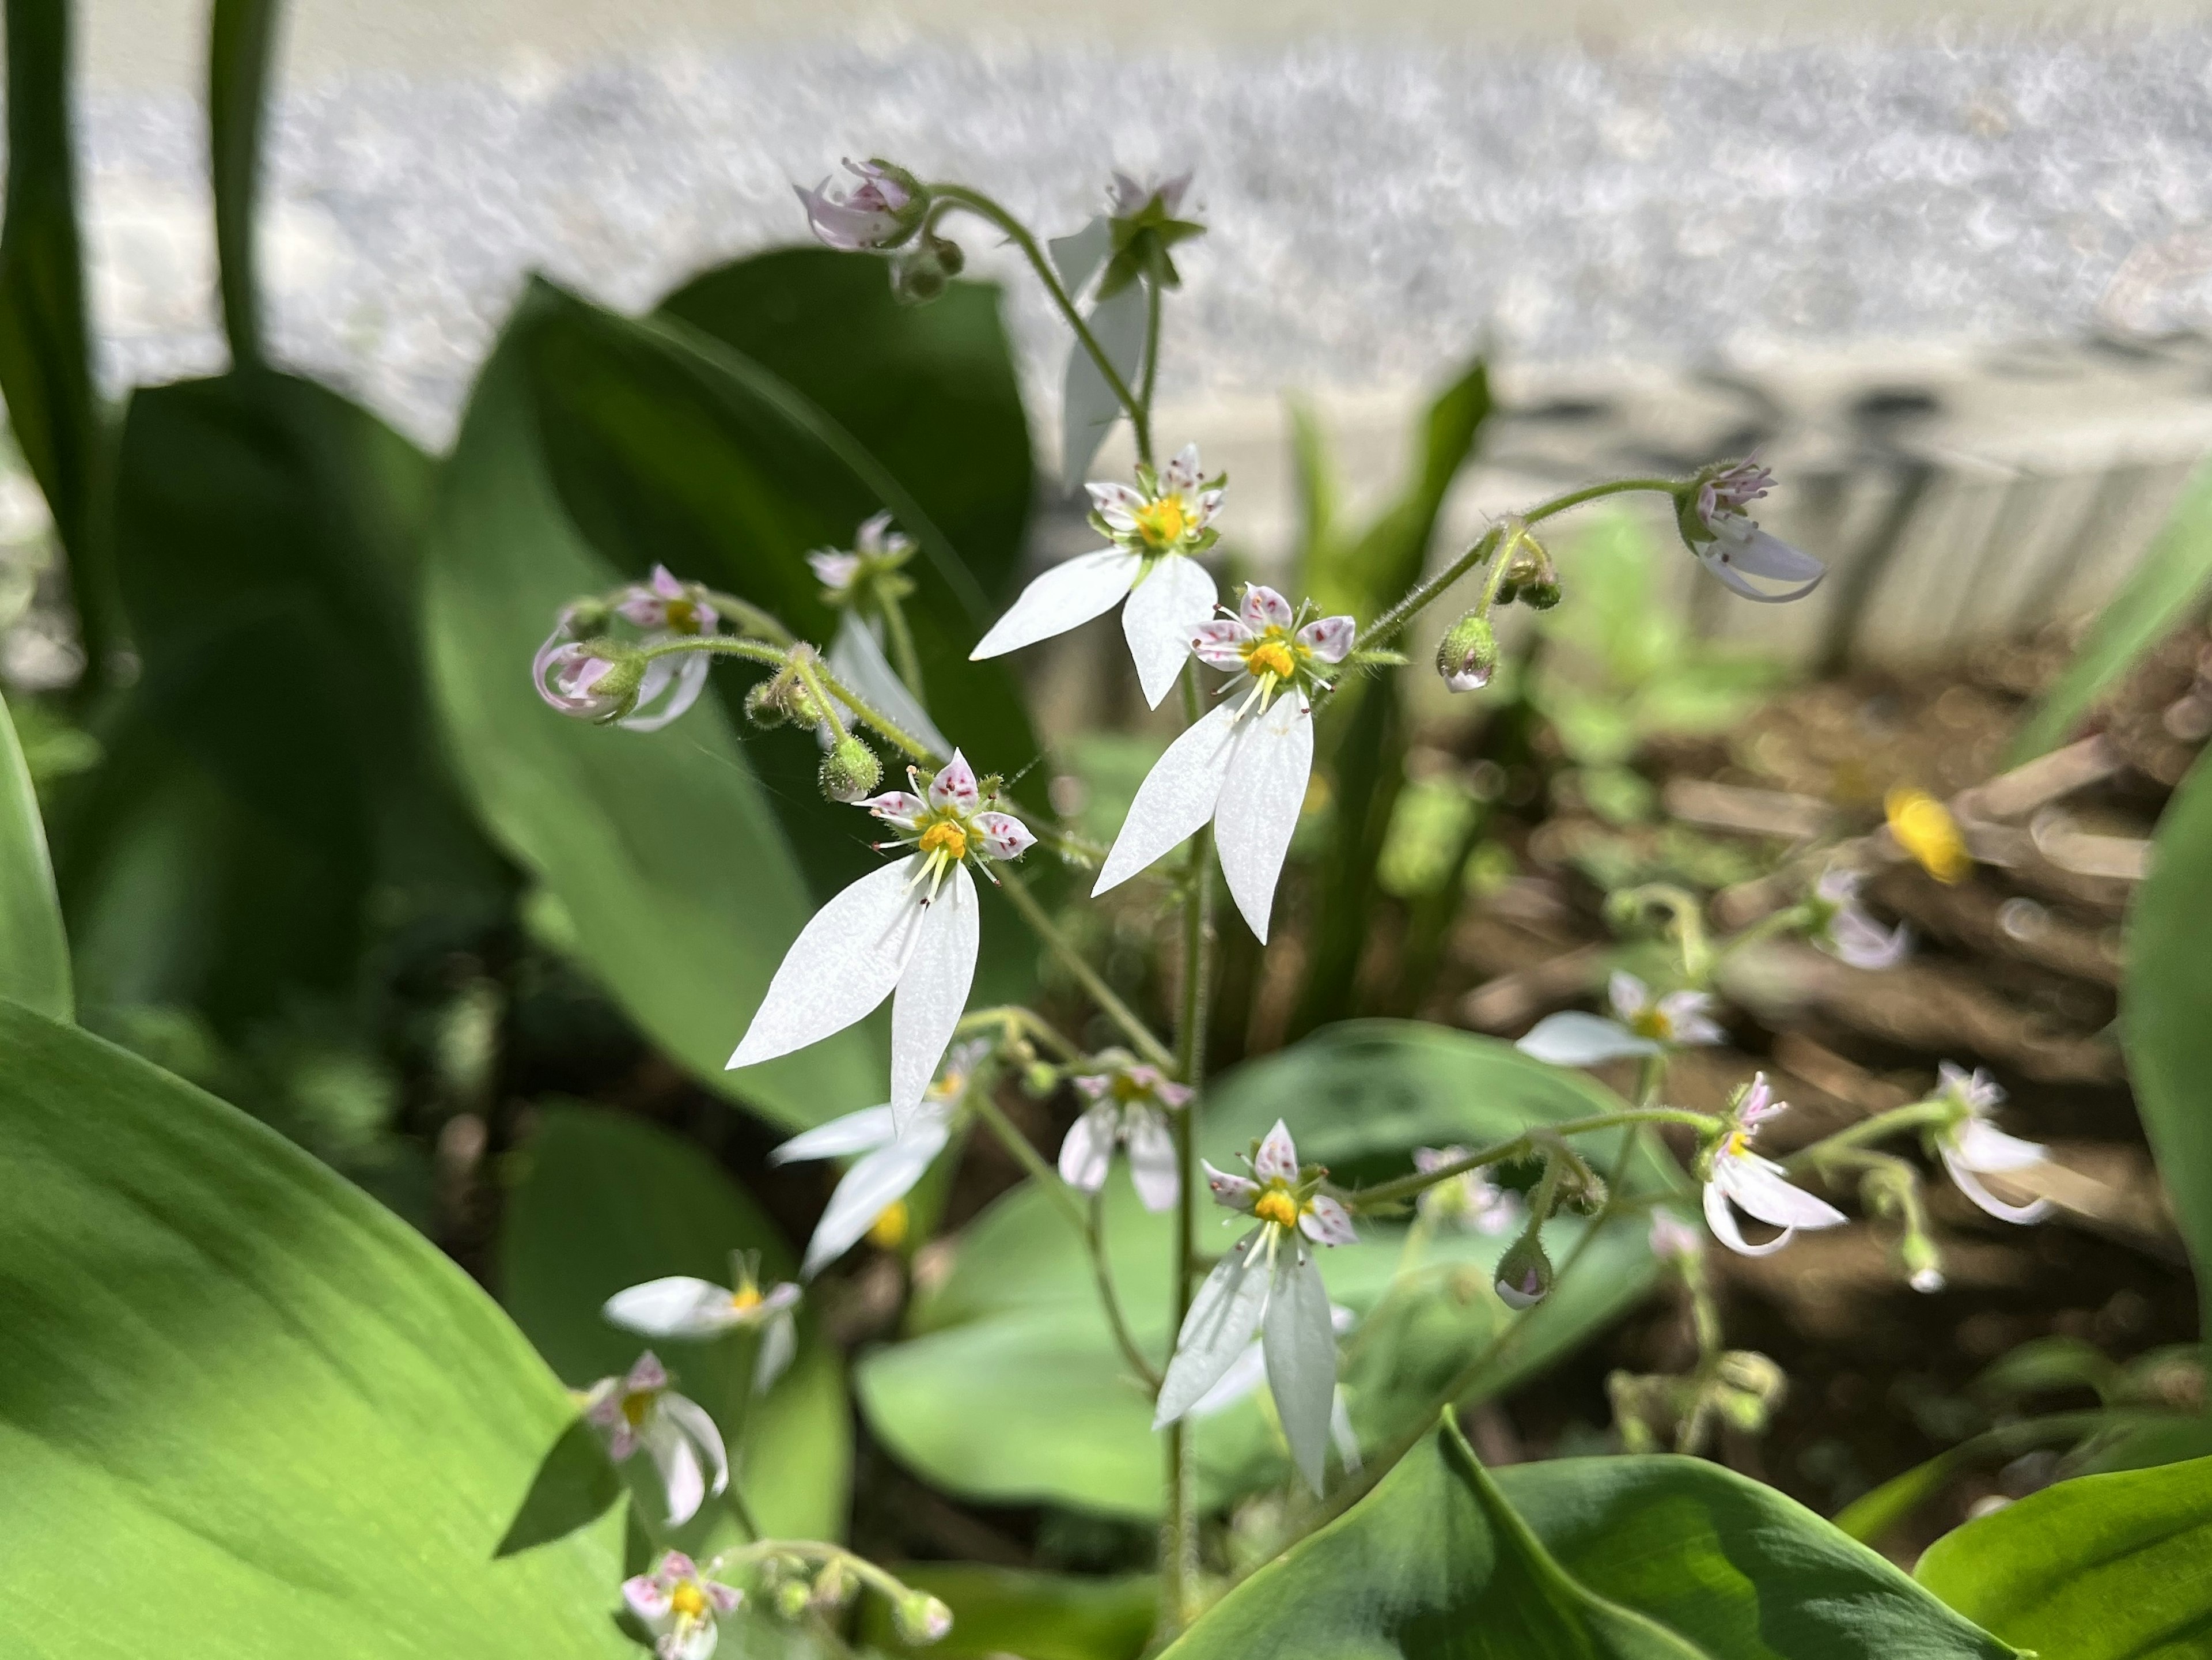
1153;1122;1358;1494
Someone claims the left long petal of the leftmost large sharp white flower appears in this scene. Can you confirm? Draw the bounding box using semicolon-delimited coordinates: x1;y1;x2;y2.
730;859;922;1067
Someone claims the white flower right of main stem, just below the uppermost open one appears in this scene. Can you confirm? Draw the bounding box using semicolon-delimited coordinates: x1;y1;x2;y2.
1090;582;1356;943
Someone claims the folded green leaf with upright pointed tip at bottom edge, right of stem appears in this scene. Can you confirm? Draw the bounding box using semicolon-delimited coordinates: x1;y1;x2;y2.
1168;1423;2009;1660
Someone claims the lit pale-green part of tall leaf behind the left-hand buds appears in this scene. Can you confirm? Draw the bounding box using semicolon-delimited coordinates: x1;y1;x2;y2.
425;286;885;1126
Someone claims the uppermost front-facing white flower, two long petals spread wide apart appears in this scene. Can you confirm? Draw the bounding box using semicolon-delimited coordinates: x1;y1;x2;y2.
969;445;1224;708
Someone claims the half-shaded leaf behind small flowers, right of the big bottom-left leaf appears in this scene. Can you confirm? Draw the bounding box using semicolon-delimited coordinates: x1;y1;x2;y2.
500;1107;851;1538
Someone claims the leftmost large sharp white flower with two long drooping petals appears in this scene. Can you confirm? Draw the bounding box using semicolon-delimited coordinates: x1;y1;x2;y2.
730;750;1035;1116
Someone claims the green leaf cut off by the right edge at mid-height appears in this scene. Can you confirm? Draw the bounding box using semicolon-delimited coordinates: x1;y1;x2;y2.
2119;753;2212;1328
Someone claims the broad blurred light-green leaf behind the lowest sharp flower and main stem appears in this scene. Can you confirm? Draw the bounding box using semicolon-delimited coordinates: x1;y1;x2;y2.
856;1035;1654;1516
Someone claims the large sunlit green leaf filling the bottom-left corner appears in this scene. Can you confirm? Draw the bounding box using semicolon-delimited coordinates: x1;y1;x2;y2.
0;1005;632;1660
